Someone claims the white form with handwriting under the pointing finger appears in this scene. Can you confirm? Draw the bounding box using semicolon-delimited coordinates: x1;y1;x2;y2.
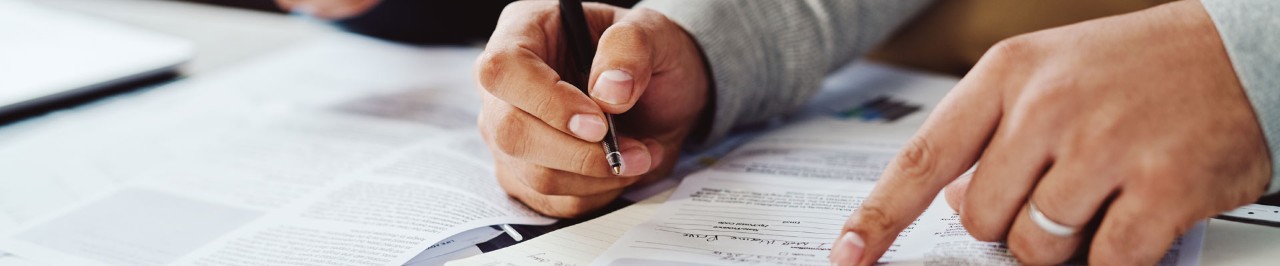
593;118;1204;266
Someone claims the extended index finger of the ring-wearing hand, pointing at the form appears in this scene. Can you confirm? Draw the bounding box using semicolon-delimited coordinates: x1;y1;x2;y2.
832;65;1001;265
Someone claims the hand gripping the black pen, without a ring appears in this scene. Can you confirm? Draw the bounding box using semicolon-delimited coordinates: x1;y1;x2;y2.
477;1;710;217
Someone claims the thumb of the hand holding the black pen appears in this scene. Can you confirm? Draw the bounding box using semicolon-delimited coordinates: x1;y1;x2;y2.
588;10;654;114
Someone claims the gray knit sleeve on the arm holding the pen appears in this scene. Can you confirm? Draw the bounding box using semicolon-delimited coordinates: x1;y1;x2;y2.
637;0;928;143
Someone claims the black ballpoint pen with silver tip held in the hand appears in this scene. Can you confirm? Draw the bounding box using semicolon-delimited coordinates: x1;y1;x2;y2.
559;0;622;175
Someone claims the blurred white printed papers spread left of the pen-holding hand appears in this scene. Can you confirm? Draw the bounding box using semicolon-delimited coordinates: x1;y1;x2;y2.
0;35;553;265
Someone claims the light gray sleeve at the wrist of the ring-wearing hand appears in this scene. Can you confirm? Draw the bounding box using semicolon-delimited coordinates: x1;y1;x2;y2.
1201;0;1280;194
